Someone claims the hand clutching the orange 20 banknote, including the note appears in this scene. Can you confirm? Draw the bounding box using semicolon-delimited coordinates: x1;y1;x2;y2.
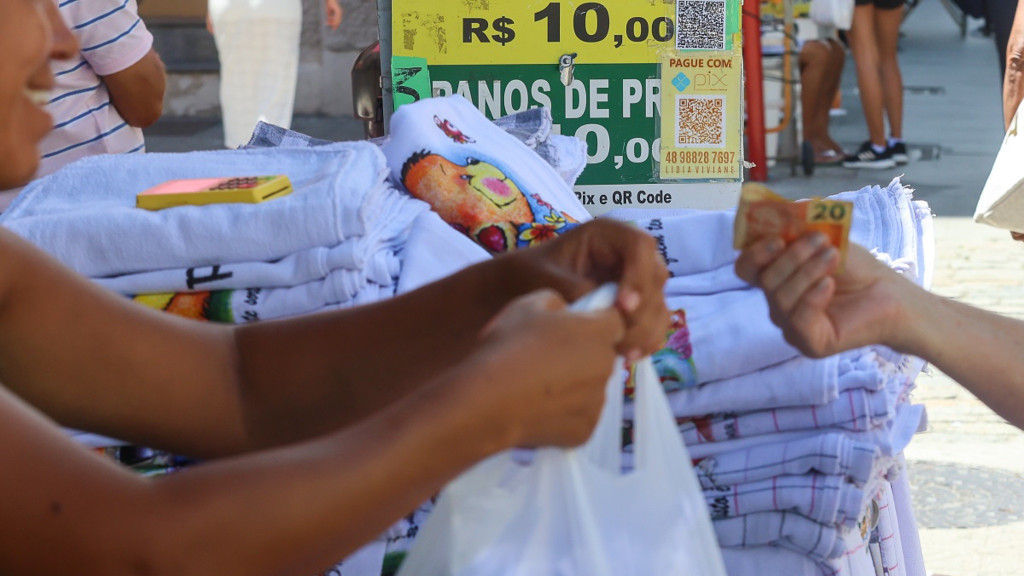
735;191;921;358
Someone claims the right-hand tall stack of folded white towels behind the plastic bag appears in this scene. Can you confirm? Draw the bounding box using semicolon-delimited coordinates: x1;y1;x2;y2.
613;176;932;576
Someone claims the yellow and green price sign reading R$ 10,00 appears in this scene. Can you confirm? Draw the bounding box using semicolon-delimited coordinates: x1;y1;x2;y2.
391;0;741;212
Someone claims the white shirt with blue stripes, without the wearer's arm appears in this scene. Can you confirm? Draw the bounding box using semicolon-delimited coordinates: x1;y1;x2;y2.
0;0;153;209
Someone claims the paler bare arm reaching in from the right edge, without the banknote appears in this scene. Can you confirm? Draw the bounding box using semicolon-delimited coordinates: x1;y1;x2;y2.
736;230;1024;428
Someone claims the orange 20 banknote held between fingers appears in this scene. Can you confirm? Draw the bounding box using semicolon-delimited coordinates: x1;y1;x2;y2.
733;183;853;270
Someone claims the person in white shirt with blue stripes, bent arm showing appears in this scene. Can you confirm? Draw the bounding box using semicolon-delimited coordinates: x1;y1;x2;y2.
0;0;166;209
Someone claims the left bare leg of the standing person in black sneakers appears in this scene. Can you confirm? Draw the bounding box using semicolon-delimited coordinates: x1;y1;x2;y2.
849;4;898;148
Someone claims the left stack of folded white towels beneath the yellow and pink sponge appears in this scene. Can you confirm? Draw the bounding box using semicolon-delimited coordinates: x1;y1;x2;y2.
0;142;436;323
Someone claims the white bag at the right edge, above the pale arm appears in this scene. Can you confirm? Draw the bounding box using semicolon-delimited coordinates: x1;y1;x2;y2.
974;99;1024;232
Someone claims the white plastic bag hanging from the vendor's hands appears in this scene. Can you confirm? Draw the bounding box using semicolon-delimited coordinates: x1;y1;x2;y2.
398;287;725;576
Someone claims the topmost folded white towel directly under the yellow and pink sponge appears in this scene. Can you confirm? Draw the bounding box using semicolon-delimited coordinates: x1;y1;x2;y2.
0;142;411;277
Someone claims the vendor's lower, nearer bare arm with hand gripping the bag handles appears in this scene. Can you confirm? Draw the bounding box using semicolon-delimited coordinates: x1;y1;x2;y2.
0;292;624;576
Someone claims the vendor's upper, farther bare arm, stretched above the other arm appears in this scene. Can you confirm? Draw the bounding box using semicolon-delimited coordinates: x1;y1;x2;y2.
0;221;668;457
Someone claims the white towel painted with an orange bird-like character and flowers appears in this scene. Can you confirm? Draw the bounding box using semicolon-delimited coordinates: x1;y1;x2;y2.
382;96;590;254
